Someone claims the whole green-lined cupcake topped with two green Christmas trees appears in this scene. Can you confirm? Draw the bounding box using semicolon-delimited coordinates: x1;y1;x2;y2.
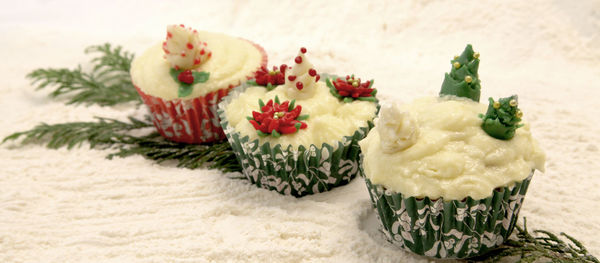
359;45;545;258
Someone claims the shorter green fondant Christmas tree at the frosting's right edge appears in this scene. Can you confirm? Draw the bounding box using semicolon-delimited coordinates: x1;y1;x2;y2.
481;95;523;140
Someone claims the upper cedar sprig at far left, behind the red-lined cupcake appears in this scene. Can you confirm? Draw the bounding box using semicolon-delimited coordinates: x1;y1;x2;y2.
27;43;141;106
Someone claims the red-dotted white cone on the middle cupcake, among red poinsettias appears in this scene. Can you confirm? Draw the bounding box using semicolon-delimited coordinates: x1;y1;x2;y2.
285;48;321;99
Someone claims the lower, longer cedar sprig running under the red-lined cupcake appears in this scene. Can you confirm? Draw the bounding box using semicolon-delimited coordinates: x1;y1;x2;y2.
2;116;241;172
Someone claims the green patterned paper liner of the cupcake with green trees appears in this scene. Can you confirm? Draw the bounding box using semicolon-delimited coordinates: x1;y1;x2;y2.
360;160;533;258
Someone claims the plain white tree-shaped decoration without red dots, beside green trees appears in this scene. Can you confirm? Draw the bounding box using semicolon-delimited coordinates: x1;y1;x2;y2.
375;104;419;153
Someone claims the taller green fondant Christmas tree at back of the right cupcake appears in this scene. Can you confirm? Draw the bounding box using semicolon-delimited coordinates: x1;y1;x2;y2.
440;44;481;102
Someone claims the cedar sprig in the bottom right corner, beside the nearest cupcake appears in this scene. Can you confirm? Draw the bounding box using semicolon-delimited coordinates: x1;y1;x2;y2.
474;218;600;263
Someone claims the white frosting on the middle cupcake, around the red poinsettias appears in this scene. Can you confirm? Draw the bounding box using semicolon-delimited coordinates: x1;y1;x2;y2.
225;81;377;148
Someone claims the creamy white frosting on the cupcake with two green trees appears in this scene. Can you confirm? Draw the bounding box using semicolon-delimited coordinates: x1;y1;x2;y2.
360;97;545;200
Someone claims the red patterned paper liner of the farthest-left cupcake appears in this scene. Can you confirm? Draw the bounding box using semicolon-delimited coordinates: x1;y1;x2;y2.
134;40;267;143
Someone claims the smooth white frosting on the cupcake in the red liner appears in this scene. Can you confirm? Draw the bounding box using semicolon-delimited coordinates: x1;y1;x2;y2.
131;31;263;100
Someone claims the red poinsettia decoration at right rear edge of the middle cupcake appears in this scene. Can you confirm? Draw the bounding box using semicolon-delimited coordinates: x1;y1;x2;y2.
327;75;377;102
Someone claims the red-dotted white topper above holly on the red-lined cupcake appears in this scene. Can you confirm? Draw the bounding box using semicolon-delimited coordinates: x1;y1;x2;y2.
163;25;212;70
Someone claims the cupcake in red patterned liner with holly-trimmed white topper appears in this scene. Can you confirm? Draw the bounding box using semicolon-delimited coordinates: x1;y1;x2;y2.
131;25;267;143
